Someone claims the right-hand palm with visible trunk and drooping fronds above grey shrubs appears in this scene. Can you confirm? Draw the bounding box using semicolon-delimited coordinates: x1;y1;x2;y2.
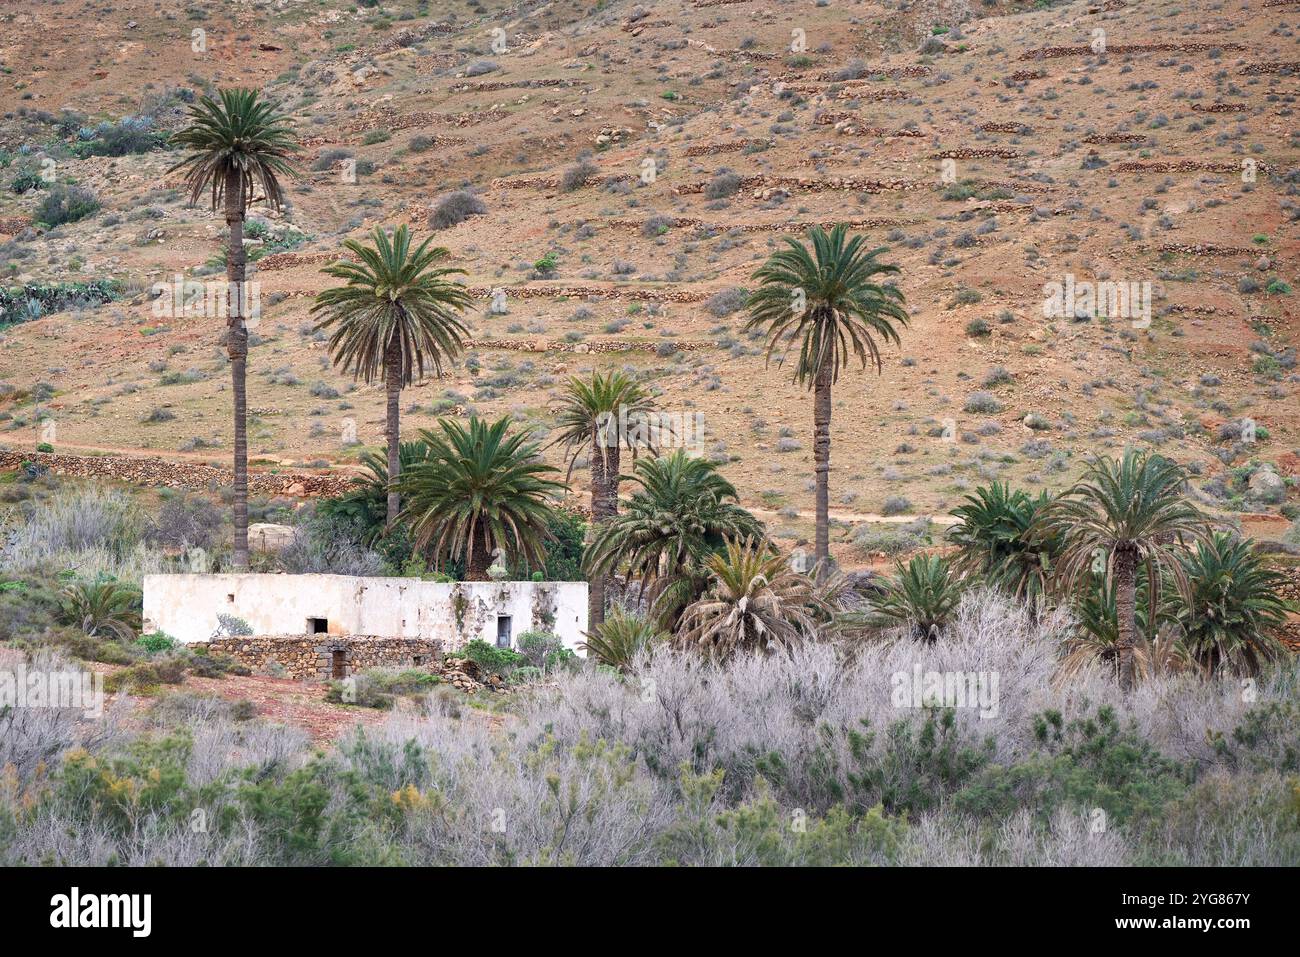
1031;449;1208;690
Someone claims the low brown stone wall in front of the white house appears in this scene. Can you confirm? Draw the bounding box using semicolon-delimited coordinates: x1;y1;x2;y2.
202;635;442;681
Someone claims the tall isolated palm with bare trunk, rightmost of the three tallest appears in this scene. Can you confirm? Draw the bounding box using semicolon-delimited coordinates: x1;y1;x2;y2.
745;224;907;568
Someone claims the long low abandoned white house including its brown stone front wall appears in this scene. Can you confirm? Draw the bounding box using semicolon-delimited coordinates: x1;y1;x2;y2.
144;573;588;679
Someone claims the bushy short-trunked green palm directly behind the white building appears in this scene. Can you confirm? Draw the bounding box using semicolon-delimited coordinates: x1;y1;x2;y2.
397;416;564;581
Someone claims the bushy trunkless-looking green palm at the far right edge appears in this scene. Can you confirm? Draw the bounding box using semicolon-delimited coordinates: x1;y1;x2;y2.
1178;532;1292;675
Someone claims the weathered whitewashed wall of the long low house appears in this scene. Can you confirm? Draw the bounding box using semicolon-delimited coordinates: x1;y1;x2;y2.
144;575;586;654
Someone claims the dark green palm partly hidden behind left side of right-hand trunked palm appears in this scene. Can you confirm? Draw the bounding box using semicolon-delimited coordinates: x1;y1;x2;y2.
948;481;1061;609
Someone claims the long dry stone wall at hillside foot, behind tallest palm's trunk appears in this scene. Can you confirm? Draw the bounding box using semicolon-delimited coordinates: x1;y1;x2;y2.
0;450;356;497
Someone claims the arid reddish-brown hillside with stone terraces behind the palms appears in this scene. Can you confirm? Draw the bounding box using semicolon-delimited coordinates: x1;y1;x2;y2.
0;0;1300;564
